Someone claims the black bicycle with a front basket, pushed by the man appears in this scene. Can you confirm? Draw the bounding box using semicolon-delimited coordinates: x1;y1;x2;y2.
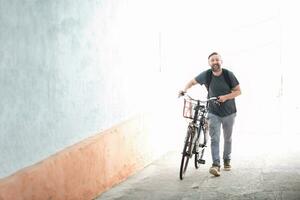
179;93;219;180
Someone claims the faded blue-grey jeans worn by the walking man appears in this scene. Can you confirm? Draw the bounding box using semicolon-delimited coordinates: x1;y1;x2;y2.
208;113;236;166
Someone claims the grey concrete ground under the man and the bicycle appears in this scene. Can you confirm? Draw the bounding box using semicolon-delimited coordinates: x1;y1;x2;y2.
96;134;300;200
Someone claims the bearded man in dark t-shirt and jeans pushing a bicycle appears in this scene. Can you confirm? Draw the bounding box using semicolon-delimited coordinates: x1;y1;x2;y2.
180;52;241;176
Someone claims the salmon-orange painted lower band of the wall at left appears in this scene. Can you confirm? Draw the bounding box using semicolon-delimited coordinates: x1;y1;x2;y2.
0;116;162;200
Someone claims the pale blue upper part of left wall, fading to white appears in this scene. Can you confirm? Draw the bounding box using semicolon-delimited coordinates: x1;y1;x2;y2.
0;0;163;178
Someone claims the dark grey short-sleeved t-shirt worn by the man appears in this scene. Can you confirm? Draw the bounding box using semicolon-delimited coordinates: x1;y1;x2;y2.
195;70;239;117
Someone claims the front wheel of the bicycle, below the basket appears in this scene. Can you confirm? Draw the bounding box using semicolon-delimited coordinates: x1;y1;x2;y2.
179;130;193;180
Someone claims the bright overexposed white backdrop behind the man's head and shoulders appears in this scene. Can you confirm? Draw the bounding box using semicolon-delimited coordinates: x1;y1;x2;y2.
162;0;300;138
